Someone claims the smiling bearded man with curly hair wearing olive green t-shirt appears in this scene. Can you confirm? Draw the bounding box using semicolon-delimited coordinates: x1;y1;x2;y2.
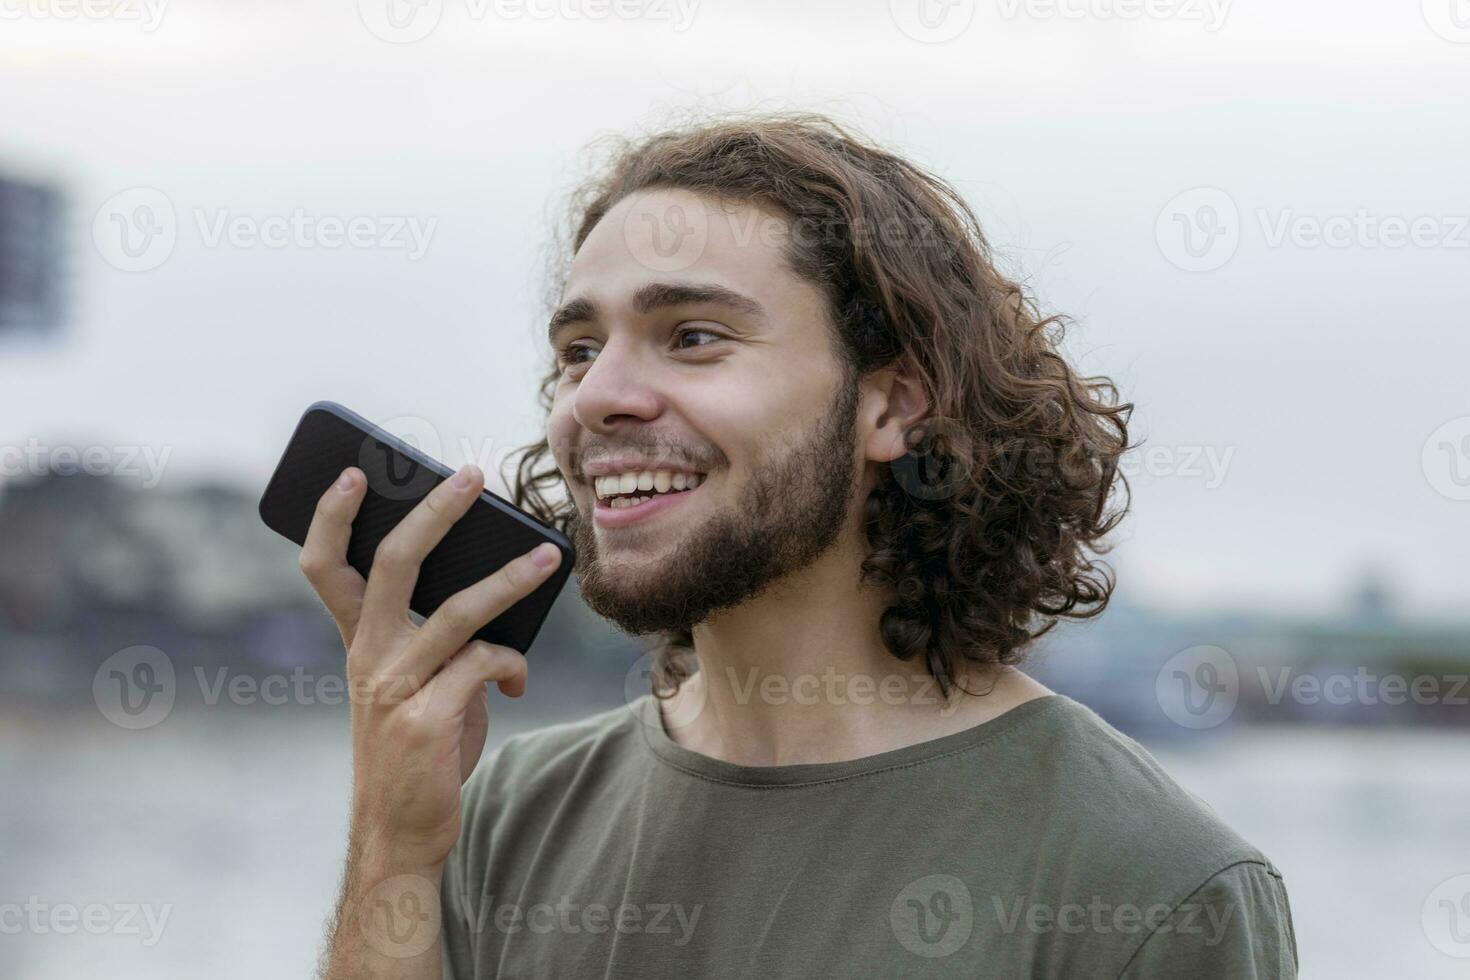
303;115;1297;980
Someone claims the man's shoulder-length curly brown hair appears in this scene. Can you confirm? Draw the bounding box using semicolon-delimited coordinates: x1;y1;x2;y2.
507;113;1133;696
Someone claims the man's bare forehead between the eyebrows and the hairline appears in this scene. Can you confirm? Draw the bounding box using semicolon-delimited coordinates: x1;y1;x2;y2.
564;188;817;309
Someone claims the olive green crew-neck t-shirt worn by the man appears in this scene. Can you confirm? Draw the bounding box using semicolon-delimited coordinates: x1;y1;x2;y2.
441;695;1297;980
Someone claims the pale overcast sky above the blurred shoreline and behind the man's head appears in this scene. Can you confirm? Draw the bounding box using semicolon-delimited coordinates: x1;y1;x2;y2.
0;0;1470;613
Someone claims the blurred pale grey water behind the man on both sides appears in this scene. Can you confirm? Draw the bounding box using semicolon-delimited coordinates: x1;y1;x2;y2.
0;705;1470;980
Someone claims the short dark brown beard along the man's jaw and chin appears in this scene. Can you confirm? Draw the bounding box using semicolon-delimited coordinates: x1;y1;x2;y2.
569;373;858;635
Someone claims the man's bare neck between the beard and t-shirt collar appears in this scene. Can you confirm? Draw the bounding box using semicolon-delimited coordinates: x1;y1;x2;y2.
662;520;1050;765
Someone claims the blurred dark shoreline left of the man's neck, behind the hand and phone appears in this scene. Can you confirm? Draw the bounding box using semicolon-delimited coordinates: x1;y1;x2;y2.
0;472;637;702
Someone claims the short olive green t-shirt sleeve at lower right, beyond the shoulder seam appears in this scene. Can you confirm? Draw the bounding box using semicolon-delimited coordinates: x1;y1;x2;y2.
1119;861;1297;980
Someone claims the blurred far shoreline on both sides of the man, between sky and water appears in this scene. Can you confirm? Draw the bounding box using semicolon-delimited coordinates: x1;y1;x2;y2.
0;472;1470;725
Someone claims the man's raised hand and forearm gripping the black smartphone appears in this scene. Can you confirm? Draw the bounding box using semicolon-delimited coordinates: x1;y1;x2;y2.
301;466;562;977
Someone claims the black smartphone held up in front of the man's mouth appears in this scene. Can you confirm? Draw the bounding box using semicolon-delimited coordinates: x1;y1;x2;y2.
260;401;576;654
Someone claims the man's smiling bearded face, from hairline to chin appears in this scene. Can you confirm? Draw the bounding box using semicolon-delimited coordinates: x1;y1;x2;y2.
547;190;860;635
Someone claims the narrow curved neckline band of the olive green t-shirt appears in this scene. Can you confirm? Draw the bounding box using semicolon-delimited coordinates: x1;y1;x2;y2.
635;692;1067;786
